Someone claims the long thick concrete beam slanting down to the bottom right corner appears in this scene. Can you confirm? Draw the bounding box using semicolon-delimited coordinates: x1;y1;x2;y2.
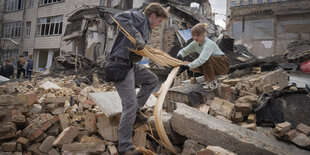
171;103;310;155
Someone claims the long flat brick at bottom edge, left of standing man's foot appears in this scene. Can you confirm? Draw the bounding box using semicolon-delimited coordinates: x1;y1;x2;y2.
61;143;105;153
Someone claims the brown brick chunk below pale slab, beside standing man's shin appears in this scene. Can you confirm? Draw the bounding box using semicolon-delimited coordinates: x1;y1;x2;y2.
97;115;118;141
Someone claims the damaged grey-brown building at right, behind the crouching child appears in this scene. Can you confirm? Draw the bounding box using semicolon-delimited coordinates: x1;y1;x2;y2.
227;0;310;57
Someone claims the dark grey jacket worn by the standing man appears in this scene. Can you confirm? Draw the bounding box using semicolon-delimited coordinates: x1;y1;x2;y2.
109;11;151;60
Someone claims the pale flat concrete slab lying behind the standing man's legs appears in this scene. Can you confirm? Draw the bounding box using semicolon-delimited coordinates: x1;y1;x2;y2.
89;89;157;117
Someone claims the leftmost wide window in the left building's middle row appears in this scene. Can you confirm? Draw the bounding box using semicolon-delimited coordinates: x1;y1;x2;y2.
3;21;21;38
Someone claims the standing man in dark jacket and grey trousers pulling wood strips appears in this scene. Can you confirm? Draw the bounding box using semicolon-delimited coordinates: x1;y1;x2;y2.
106;3;168;155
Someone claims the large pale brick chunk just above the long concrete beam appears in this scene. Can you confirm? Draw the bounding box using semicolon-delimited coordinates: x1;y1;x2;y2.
210;98;234;120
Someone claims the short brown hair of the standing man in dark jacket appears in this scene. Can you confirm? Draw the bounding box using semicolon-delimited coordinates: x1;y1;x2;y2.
143;3;168;19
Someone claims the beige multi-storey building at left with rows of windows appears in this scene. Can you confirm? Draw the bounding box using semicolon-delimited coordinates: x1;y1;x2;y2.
0;0;102;68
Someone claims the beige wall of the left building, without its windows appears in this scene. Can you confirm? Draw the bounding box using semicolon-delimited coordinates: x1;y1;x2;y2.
0;0;100;67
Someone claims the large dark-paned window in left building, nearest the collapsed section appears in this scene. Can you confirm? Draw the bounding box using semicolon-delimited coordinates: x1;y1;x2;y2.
37;16;63;36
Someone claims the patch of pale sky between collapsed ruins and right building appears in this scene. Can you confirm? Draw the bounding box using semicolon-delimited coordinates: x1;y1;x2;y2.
209;0;226;28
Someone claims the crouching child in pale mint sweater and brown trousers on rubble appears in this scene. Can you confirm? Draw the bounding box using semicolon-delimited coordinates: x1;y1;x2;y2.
177;23;230;90
